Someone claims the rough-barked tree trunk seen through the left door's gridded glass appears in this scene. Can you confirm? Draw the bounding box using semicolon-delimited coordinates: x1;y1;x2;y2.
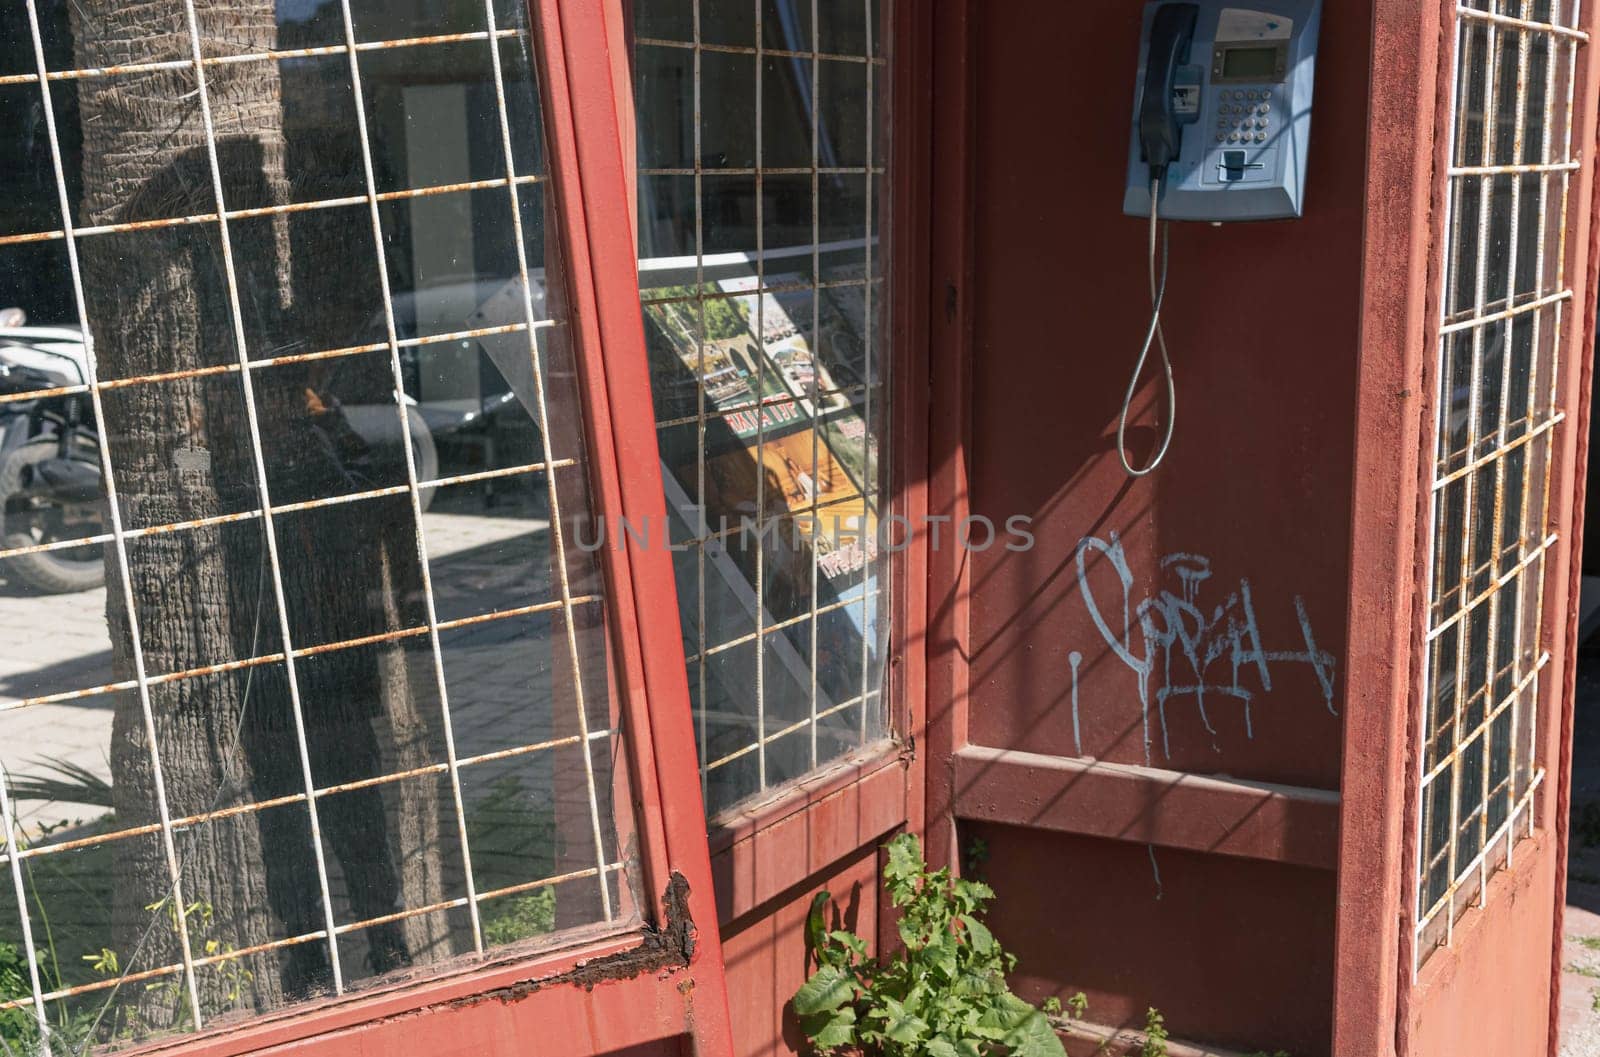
72;0;462;1036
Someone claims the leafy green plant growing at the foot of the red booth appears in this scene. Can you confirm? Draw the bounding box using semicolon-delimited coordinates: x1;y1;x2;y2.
794;833;1066;1057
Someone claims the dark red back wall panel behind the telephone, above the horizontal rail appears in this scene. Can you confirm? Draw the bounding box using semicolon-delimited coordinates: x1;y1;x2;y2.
970;2;1371;788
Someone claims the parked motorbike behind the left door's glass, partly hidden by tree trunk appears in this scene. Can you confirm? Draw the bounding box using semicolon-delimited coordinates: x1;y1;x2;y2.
0;309;438;595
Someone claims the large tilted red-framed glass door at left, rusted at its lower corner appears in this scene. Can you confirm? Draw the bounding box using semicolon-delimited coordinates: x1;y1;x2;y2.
0;0;731;1057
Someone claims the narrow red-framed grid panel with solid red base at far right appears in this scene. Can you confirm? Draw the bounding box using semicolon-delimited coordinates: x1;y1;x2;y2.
1398;0;1595;1054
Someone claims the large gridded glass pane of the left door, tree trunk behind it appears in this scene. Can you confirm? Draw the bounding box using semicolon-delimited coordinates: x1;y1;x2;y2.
0;0;634;1055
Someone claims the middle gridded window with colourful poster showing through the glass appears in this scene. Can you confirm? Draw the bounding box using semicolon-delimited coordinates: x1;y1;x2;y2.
634;0;888;814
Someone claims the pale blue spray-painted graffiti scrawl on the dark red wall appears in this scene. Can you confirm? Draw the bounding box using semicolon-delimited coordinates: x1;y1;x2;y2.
1070;532;1338;763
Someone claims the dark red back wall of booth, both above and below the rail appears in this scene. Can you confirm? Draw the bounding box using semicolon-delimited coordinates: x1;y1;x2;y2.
936;0;1371;1055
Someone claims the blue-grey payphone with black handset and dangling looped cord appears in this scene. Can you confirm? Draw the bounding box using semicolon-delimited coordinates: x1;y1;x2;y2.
1117;0;1322;477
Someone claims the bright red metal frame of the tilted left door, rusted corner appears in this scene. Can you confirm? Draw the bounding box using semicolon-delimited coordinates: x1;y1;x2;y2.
101;0;733;1057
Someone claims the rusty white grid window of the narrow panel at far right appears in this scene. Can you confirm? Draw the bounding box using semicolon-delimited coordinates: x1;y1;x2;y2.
1413;0;1586;969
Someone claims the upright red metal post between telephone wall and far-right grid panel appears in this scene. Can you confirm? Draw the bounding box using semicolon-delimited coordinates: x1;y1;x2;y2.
1333;0;1442;1057
